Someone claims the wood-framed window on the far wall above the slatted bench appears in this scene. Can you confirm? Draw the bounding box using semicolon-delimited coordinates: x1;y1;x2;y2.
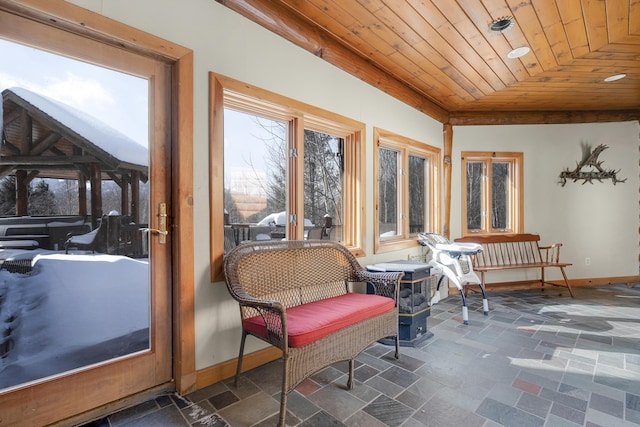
462;152;523;235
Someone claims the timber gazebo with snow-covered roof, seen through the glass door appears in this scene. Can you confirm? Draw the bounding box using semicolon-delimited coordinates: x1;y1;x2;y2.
0;88;149;231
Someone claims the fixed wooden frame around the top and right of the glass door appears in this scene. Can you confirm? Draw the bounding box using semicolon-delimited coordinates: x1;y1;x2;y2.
0;0;196;422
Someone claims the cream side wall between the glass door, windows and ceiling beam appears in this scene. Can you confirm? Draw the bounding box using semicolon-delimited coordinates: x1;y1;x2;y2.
67;0;442;369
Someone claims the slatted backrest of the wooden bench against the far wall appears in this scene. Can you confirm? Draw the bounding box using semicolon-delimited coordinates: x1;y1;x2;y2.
455;234;543;267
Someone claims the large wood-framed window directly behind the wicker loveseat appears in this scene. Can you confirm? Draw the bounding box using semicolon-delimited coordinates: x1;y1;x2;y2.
210;74;364;280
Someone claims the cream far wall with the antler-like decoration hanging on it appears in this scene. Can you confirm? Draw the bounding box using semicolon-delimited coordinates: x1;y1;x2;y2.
451;121;640;281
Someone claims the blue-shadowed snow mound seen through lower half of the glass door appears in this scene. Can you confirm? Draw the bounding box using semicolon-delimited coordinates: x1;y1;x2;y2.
0;251;150;389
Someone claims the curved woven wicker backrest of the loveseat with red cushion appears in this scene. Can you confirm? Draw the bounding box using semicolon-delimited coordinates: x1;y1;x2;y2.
224;240;362;314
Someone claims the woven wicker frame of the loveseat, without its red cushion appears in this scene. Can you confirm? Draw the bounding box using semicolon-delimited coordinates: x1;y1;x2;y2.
224;240;402;426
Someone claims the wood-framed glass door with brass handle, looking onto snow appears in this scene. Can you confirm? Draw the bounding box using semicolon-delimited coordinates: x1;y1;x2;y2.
0;12;172;425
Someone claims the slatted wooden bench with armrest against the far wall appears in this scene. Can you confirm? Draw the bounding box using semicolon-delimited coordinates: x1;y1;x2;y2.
455;234;573;298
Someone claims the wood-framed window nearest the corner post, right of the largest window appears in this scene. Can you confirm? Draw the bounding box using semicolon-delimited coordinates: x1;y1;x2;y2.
374;129;440;252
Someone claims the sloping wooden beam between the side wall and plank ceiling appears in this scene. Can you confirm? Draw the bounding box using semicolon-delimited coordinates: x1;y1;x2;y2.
217;0;448;123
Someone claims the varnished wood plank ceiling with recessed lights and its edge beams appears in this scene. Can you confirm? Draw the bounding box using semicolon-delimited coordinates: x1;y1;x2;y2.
219;0;640;124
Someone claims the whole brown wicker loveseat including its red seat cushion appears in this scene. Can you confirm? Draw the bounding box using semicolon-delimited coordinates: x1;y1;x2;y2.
224;240;402;426
